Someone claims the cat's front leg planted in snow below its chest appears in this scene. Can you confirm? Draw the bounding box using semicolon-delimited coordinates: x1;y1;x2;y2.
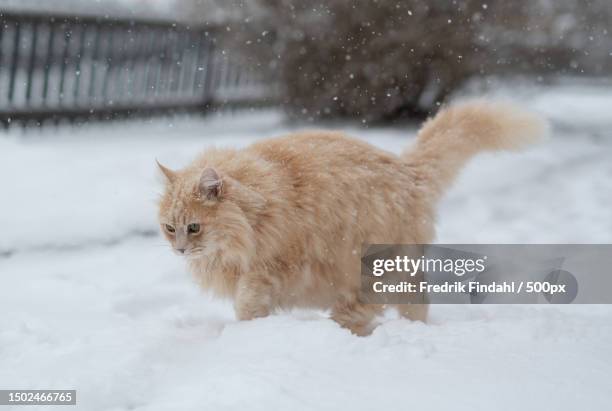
234;274;274;321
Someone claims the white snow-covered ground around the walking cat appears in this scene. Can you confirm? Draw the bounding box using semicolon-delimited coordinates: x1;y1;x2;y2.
0;84;612;411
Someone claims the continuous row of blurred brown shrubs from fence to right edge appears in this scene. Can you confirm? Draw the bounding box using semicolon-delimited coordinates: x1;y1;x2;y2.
217;0;612;121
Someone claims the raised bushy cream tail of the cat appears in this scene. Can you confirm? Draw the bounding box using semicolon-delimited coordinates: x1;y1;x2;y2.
402;101;548;201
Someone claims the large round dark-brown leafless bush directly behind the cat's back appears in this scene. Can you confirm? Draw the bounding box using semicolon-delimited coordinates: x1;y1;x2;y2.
222;0;484;121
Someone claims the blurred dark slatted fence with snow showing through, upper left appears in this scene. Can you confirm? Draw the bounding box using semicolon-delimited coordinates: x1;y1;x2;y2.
0;11;271;126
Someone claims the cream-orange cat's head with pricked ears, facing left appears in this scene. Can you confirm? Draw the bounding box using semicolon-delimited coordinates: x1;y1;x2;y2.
158;163;265;269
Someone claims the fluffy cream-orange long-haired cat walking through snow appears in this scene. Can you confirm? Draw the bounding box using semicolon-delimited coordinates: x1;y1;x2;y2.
158;102;547;335
